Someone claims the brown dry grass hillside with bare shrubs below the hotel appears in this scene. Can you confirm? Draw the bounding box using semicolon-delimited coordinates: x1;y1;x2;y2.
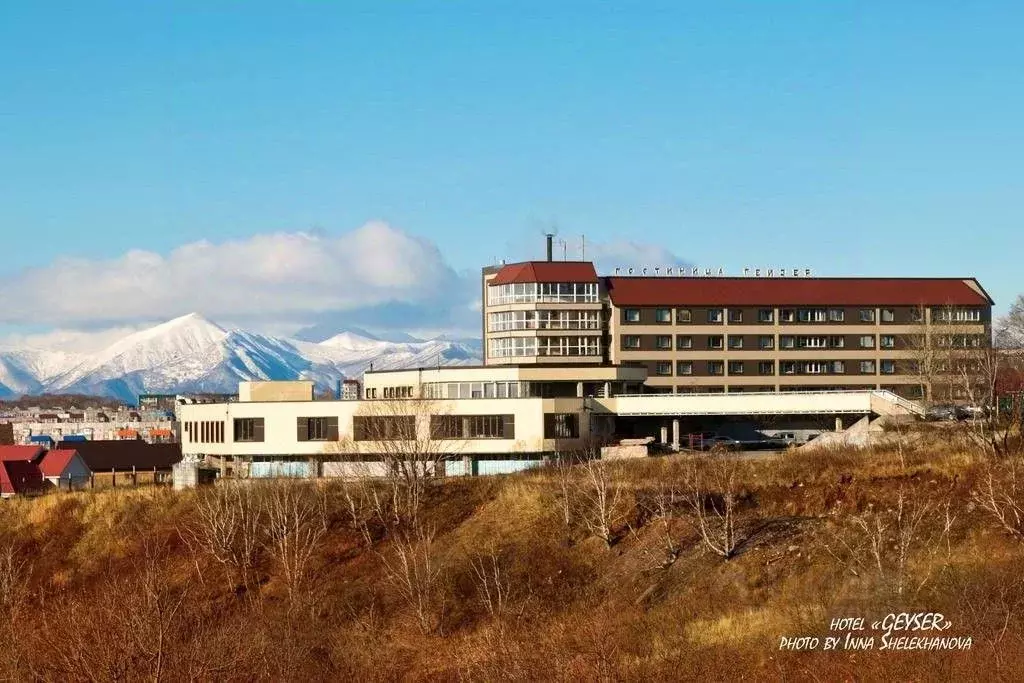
0;446;1024;681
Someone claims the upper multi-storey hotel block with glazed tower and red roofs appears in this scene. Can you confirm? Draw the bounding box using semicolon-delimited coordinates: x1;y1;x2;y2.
482;239;992;398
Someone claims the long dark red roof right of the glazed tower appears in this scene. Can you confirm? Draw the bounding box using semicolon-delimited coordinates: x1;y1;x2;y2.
606;278;992;307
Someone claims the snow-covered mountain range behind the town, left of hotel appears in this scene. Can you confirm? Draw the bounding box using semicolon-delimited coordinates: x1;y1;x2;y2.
0;313;480;402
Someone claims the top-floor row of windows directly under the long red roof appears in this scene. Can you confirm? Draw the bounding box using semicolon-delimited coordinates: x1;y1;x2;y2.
623;308;981;324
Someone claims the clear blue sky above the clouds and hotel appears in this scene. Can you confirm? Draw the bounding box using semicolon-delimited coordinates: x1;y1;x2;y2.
0;0;1024;339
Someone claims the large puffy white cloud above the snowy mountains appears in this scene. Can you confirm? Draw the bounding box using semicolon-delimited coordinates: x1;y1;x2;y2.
0;222;460;326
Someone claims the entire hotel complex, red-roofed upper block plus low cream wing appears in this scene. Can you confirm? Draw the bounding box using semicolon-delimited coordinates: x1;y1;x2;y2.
178;237;992;476
